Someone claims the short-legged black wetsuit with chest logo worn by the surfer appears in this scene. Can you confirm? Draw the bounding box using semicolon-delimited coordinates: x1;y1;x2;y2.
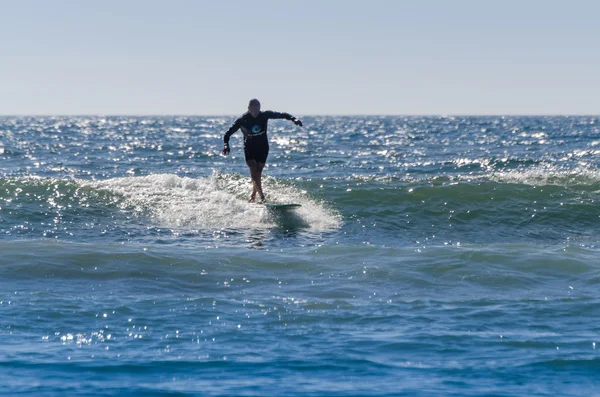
223;110;296;164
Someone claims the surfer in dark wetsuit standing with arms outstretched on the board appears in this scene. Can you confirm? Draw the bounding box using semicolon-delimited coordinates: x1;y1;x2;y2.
222;99;302;203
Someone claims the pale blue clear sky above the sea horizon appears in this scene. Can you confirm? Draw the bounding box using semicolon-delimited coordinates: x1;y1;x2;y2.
0;0;600;115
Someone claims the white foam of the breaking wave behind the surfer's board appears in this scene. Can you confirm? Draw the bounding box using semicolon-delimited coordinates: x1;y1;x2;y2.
80;172;342;231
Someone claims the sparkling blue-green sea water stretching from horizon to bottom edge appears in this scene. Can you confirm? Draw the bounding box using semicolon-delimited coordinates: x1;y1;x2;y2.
0;116;600;396
